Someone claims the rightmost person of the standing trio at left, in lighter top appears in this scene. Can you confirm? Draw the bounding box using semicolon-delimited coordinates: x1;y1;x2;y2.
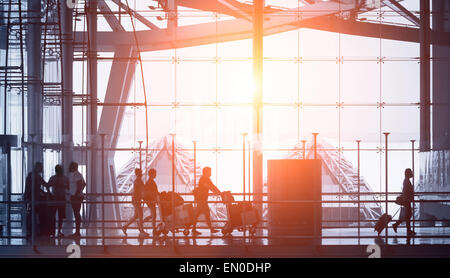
68;162;86;237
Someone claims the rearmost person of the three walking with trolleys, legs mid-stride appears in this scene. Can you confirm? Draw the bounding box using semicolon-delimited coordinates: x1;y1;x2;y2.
122;168;148;237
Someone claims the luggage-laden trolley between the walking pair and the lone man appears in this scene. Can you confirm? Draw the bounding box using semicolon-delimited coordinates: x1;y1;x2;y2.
154;192;194;236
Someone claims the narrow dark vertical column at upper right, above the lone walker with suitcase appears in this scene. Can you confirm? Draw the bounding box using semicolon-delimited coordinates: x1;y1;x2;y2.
420;0;431;152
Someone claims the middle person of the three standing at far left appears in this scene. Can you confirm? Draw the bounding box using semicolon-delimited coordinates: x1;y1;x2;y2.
48;164;70;237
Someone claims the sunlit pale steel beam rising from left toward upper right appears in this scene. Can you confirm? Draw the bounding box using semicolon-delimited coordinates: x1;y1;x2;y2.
75;2;358;52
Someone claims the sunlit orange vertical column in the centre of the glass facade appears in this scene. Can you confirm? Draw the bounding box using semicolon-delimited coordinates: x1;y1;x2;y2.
253;0;264;212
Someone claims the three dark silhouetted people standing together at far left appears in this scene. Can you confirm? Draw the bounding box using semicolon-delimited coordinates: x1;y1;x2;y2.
24;162;86;237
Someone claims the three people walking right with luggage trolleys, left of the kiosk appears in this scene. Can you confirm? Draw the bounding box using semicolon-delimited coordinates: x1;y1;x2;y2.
122;167;222;236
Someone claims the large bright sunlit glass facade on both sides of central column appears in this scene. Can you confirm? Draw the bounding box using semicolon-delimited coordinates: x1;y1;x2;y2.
96;1;419;213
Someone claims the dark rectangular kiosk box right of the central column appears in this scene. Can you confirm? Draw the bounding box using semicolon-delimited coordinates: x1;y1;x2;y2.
267;159;322;245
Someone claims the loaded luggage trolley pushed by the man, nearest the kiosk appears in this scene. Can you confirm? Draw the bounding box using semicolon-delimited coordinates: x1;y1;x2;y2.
222;191;261;235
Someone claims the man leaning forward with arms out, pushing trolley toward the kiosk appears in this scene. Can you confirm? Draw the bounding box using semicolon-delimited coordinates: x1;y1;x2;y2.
192;167;222;235
